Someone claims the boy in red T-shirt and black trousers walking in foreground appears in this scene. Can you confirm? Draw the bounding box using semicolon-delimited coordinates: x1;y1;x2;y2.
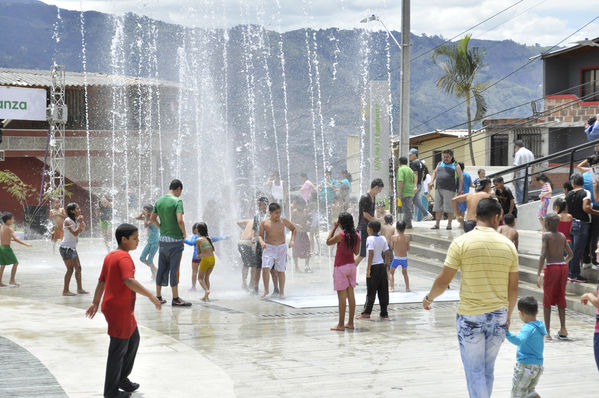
85;224;161;398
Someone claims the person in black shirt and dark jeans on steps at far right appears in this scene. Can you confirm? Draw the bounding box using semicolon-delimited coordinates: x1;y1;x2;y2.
566;173;599;283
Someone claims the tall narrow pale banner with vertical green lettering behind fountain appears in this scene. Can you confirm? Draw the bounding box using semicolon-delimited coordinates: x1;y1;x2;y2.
365;80;393;199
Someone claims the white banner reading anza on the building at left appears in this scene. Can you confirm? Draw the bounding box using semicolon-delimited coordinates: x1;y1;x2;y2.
0;87;46;121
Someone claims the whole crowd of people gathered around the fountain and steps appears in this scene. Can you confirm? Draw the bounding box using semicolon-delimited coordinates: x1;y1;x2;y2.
5;143;599;397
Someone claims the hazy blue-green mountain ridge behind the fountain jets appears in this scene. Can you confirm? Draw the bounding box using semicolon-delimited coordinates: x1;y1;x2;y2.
0;0;545;172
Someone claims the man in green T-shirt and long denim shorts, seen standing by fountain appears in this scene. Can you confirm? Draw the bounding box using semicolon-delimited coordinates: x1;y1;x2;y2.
150;180;191;307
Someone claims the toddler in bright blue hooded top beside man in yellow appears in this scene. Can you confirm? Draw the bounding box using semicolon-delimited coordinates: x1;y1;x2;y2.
505;297;547;398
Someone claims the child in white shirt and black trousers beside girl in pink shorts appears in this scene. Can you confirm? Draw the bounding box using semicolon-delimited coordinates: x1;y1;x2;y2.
358;220;390;319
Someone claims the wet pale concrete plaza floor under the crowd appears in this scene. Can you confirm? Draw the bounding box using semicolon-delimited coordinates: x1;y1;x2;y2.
0;229;599;398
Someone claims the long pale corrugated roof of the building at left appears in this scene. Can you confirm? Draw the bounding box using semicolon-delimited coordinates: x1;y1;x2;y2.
0;68;179;87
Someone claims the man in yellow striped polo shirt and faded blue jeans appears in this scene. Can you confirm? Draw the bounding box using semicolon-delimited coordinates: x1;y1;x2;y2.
422;198;518;398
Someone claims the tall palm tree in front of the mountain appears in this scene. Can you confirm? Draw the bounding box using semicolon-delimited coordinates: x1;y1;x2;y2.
433;35;487;166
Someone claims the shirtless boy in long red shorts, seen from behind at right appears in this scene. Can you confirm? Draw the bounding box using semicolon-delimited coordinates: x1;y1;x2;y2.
537;213;573;340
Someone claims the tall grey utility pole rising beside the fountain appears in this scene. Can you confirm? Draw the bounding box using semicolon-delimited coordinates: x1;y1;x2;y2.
399;0;410;158
